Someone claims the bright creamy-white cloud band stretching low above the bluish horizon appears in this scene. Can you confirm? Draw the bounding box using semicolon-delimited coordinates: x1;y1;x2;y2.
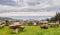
0;12;56;16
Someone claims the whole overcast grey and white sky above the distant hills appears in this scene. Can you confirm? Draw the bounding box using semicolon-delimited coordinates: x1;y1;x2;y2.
0;0;60;19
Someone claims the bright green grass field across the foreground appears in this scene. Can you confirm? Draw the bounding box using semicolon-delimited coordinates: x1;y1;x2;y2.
0;26;60;35
